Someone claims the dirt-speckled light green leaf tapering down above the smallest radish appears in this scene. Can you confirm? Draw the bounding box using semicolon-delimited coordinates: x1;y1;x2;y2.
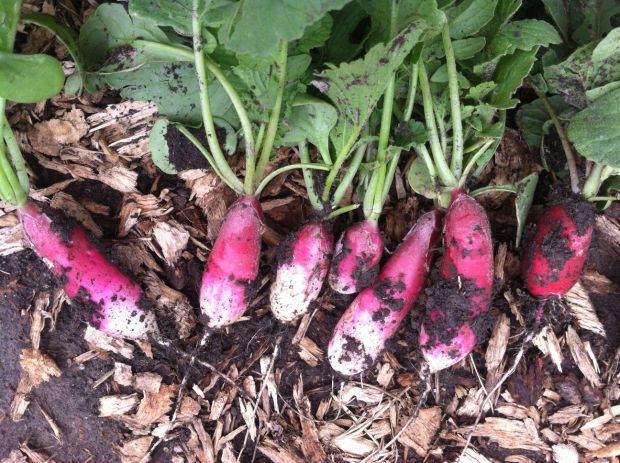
312;19;434;158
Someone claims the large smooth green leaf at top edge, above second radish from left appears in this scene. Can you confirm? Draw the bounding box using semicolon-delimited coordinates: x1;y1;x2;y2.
226;0;350;56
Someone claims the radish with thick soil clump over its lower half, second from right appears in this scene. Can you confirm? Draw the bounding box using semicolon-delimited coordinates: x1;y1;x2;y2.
420;189;493;371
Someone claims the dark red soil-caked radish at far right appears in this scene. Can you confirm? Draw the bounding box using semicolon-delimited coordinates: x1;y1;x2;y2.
521;205;593;298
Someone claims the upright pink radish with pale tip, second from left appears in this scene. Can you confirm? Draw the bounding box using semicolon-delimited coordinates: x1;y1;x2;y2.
200;196;264;328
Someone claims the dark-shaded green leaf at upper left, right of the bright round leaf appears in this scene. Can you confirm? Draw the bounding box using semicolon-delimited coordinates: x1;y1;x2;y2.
78;3;168;69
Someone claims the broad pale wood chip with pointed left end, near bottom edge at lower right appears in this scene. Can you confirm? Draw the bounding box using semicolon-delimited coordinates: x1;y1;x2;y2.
457;417;551;452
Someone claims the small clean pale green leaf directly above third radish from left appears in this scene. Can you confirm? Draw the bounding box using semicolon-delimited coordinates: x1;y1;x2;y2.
282;95;338;161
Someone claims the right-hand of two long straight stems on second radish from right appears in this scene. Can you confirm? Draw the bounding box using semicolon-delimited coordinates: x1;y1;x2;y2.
441;24;463;178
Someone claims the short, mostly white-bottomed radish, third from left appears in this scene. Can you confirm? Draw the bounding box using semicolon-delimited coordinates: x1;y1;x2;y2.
270;222;334;323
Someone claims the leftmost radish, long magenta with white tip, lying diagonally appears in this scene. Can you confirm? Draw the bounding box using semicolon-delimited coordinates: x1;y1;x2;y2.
17;203;159;340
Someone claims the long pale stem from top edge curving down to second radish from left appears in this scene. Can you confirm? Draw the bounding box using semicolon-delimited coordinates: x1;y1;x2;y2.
192;0;242;194
